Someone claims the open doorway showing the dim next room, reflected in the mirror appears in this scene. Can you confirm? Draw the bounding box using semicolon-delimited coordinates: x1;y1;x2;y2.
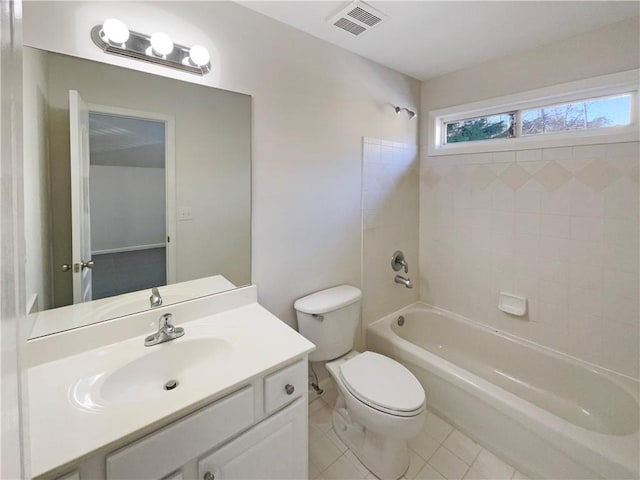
89;110;168;300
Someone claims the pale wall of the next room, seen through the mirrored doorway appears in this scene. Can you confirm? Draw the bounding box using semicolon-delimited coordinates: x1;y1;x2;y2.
89;165;167;253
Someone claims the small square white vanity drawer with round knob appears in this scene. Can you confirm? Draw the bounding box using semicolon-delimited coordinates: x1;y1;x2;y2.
264;360;307;415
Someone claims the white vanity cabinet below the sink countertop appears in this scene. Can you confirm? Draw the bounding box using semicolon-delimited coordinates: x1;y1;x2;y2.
51;356;308;480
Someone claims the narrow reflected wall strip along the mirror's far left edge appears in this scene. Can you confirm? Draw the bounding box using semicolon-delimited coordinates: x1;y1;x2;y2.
22;50;53;311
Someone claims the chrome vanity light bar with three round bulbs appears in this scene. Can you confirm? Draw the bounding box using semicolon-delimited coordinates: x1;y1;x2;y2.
91;18;211;75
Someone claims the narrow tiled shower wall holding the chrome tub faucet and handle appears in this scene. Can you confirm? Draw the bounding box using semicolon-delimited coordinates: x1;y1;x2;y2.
362;137;420;326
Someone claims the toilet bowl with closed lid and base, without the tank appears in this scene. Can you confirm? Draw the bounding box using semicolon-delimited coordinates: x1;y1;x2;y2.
326;351;426;479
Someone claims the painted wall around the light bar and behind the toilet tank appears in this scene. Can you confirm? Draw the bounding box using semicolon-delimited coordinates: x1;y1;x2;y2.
25;2;420;325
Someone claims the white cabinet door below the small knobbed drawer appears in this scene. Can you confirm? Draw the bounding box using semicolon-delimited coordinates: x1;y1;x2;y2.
198;398;307;480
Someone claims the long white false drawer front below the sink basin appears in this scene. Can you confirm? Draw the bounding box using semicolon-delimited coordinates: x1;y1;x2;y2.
107;386;254;480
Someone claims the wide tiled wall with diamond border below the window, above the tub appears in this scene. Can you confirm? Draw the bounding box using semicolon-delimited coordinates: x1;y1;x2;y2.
419;142;640;378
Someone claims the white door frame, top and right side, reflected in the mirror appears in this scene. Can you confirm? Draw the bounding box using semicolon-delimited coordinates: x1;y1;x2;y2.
87;103;178;284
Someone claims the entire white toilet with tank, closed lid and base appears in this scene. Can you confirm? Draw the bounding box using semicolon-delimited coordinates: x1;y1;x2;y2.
294;285;426;479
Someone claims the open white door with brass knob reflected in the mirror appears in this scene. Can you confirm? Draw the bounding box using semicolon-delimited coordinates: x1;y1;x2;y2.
69;90;93;303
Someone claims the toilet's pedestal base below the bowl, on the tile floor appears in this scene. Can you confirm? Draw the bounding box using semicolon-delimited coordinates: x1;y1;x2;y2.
332;405;409;480
